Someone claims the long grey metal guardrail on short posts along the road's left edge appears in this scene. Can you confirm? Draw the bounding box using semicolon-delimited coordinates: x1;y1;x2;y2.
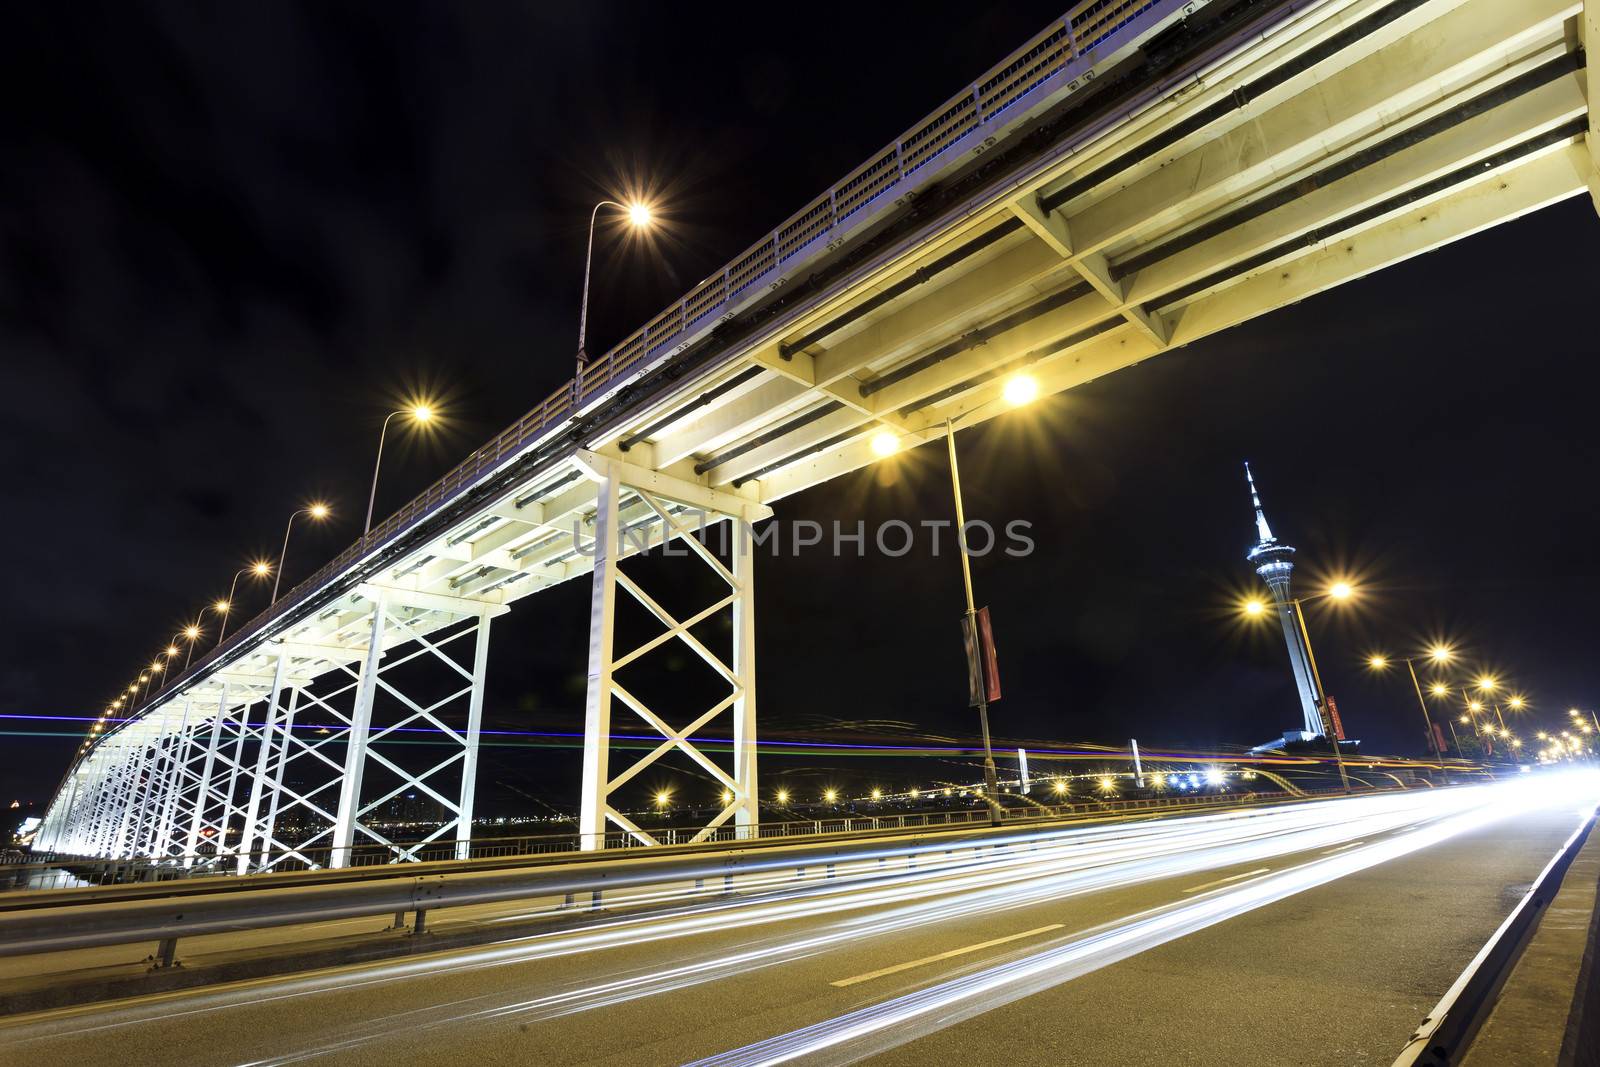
0;790;1299;966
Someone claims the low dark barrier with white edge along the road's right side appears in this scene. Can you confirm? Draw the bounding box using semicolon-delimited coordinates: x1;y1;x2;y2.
1394;813;1595;1067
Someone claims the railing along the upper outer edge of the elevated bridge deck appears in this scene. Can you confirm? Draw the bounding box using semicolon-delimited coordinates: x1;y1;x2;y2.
103;0;1206;742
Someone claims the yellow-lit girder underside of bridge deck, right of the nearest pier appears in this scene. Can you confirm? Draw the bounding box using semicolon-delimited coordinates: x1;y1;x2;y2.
613;0;1597;502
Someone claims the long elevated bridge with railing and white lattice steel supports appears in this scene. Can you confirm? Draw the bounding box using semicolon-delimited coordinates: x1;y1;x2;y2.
37;0;1600;873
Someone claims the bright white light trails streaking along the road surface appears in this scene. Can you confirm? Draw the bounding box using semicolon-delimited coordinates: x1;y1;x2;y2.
0;782;1571;1064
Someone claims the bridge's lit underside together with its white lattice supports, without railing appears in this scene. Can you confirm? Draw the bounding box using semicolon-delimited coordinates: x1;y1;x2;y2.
40;0;1600;870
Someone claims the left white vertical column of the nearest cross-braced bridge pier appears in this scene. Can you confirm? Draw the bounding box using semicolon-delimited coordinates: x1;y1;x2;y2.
578;477;618;851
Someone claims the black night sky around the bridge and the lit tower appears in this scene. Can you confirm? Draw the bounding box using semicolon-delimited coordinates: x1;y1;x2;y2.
0;3;1600;809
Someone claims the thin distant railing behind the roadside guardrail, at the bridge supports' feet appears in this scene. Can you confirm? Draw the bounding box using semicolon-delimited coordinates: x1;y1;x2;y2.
15;790;1291;899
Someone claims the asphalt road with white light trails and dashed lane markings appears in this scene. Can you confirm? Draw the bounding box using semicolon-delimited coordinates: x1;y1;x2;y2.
0;781;1594;1067
